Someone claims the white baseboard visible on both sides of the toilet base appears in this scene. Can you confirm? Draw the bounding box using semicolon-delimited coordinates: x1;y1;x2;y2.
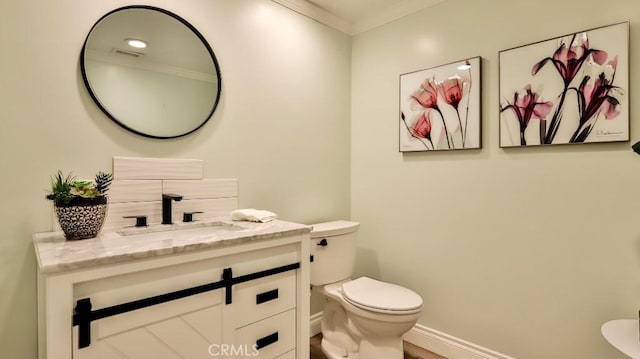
309;312;515;359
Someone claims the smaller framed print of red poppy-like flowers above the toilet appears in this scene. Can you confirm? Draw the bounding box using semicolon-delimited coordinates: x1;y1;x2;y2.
400;57;481;152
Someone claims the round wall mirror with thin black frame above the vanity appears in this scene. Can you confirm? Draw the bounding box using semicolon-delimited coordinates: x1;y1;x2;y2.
80;6;222;138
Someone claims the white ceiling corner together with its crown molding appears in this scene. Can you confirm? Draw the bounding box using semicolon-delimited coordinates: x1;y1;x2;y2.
273;0;446;35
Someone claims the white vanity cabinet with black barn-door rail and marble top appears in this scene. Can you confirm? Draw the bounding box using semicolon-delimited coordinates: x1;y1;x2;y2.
34;221;309;359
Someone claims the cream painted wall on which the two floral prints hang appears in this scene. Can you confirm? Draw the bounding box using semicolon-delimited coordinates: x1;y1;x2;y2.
351;0;640;359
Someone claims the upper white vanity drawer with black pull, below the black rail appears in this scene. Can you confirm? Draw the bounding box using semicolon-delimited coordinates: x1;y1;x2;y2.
233;271;296;328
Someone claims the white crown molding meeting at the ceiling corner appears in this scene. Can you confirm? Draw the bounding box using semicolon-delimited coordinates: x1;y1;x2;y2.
272;0;445;36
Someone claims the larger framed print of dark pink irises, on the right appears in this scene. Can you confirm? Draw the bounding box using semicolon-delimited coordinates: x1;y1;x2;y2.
499;22;629;147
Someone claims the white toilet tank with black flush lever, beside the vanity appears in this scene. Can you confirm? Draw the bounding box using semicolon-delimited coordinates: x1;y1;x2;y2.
311;221;360;286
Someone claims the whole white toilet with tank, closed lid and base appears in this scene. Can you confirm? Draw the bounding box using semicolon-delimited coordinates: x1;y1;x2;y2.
311;221;422;359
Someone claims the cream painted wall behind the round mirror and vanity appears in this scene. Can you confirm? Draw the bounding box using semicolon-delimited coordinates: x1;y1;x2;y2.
0;0;351;359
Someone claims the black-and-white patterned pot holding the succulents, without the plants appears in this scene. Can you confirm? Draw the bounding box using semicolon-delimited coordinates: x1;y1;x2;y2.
55;196;107;240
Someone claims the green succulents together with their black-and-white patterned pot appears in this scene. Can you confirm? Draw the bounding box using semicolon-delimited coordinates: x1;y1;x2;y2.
46;170;113;240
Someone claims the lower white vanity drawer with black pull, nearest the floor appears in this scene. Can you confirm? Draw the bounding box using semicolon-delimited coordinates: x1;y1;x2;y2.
235;309;296;359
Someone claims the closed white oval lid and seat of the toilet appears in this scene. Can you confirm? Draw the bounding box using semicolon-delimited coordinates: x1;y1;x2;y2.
342;277;422;311
